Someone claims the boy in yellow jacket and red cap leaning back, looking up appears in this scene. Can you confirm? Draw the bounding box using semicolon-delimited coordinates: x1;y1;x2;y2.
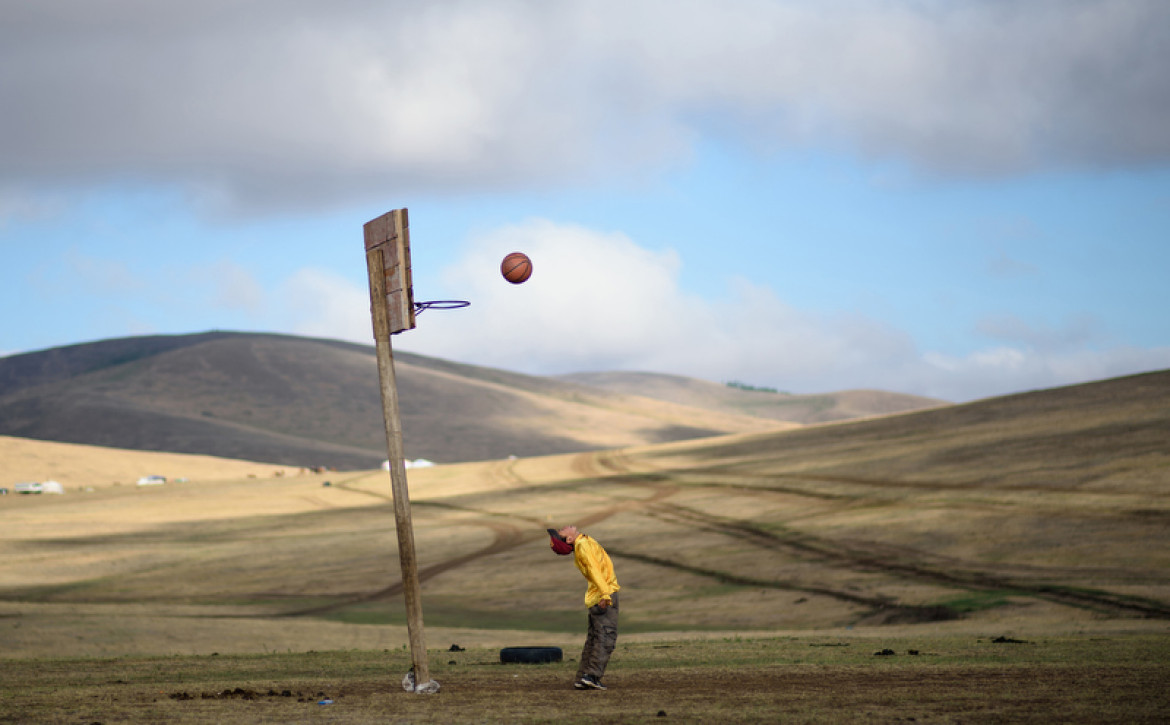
549;526;621;690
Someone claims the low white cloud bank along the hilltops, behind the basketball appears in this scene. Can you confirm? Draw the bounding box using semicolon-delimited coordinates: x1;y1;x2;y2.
271;219;1170;401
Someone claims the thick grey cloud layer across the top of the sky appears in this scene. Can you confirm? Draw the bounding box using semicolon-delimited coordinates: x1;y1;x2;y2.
0;0;1170;208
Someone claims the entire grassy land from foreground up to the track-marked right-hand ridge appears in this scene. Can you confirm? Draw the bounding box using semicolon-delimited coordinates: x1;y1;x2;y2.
0;373;1170;723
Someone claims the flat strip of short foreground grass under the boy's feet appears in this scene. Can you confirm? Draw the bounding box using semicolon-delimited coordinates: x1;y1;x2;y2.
0;635;1170;724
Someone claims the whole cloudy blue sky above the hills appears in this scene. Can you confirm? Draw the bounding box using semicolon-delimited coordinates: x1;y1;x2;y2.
0;0;1170;402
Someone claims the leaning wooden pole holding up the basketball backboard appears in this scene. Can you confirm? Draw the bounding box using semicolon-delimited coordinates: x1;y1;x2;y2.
366;212;439;692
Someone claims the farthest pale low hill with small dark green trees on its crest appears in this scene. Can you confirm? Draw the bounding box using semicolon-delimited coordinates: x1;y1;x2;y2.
558;372;950;424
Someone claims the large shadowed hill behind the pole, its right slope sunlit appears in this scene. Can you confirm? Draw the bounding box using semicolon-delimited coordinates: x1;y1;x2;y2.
0;332;936;469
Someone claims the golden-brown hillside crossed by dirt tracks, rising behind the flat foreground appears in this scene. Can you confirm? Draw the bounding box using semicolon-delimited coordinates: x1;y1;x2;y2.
0;372;1170;660
